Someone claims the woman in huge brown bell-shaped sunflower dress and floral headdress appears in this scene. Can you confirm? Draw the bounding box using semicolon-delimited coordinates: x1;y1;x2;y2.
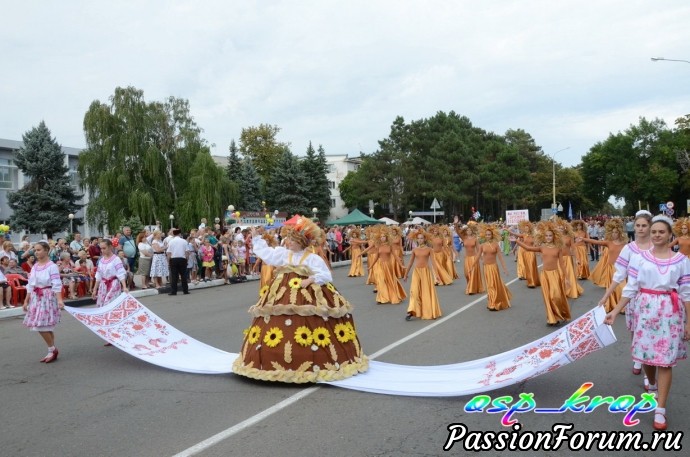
232;217;368;383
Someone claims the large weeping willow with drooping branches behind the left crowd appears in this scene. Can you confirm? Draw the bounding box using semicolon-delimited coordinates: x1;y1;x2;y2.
79;87;233;227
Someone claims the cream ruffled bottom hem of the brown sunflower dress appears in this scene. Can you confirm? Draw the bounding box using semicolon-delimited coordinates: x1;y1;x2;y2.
232;356;369;384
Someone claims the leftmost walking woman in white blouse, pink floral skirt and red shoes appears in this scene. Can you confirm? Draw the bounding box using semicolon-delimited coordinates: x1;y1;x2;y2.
22;241;64;363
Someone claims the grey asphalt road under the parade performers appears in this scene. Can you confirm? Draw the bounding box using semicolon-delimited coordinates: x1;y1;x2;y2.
0;255;690;457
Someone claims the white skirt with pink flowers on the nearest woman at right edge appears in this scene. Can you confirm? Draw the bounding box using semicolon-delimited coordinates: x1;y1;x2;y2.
626;292;688;367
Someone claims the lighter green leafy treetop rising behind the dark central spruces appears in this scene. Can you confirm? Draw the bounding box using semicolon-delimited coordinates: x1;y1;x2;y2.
240;124;290;184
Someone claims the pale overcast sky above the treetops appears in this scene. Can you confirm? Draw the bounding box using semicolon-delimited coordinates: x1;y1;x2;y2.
0;0;690;166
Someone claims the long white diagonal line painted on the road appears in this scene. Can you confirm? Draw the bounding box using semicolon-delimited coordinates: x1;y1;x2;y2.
173;272;518;457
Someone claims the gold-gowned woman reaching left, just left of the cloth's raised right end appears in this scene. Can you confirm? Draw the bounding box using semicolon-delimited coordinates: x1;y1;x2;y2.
517;221;574;326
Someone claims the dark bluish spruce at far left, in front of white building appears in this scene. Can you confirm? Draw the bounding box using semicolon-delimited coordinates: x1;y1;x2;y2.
7;121;82;237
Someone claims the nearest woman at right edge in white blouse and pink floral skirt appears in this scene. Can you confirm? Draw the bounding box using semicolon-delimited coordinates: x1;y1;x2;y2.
604;216;690;430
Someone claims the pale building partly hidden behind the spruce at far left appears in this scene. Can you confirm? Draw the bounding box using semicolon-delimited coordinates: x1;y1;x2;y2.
0;138;91;242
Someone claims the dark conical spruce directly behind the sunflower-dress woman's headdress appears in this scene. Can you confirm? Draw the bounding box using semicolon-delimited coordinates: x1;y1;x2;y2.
266;151;311;215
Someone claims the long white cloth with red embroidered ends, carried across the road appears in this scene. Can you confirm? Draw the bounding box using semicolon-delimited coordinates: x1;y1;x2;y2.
65;294;616;397
